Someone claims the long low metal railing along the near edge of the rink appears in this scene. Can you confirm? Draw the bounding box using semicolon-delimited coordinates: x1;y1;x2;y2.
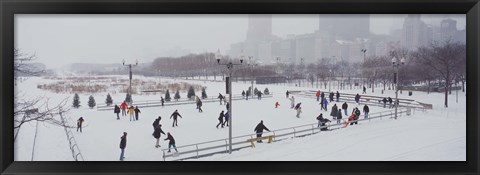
161;108;411;161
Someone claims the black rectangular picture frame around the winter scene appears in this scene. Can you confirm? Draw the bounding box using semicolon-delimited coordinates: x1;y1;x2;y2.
0;0;480;174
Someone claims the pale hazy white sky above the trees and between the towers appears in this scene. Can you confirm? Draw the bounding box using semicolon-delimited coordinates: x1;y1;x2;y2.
15;14;465;68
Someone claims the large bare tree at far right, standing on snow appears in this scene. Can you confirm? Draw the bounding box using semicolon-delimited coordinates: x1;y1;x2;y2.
412;41;466;108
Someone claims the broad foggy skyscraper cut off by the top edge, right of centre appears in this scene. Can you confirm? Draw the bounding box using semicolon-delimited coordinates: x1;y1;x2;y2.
318;14;370;40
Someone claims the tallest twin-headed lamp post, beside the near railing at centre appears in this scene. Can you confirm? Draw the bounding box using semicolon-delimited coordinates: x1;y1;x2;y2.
216;49;243;154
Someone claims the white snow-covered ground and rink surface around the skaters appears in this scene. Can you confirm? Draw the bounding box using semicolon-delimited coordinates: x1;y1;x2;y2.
15;76;466;161
